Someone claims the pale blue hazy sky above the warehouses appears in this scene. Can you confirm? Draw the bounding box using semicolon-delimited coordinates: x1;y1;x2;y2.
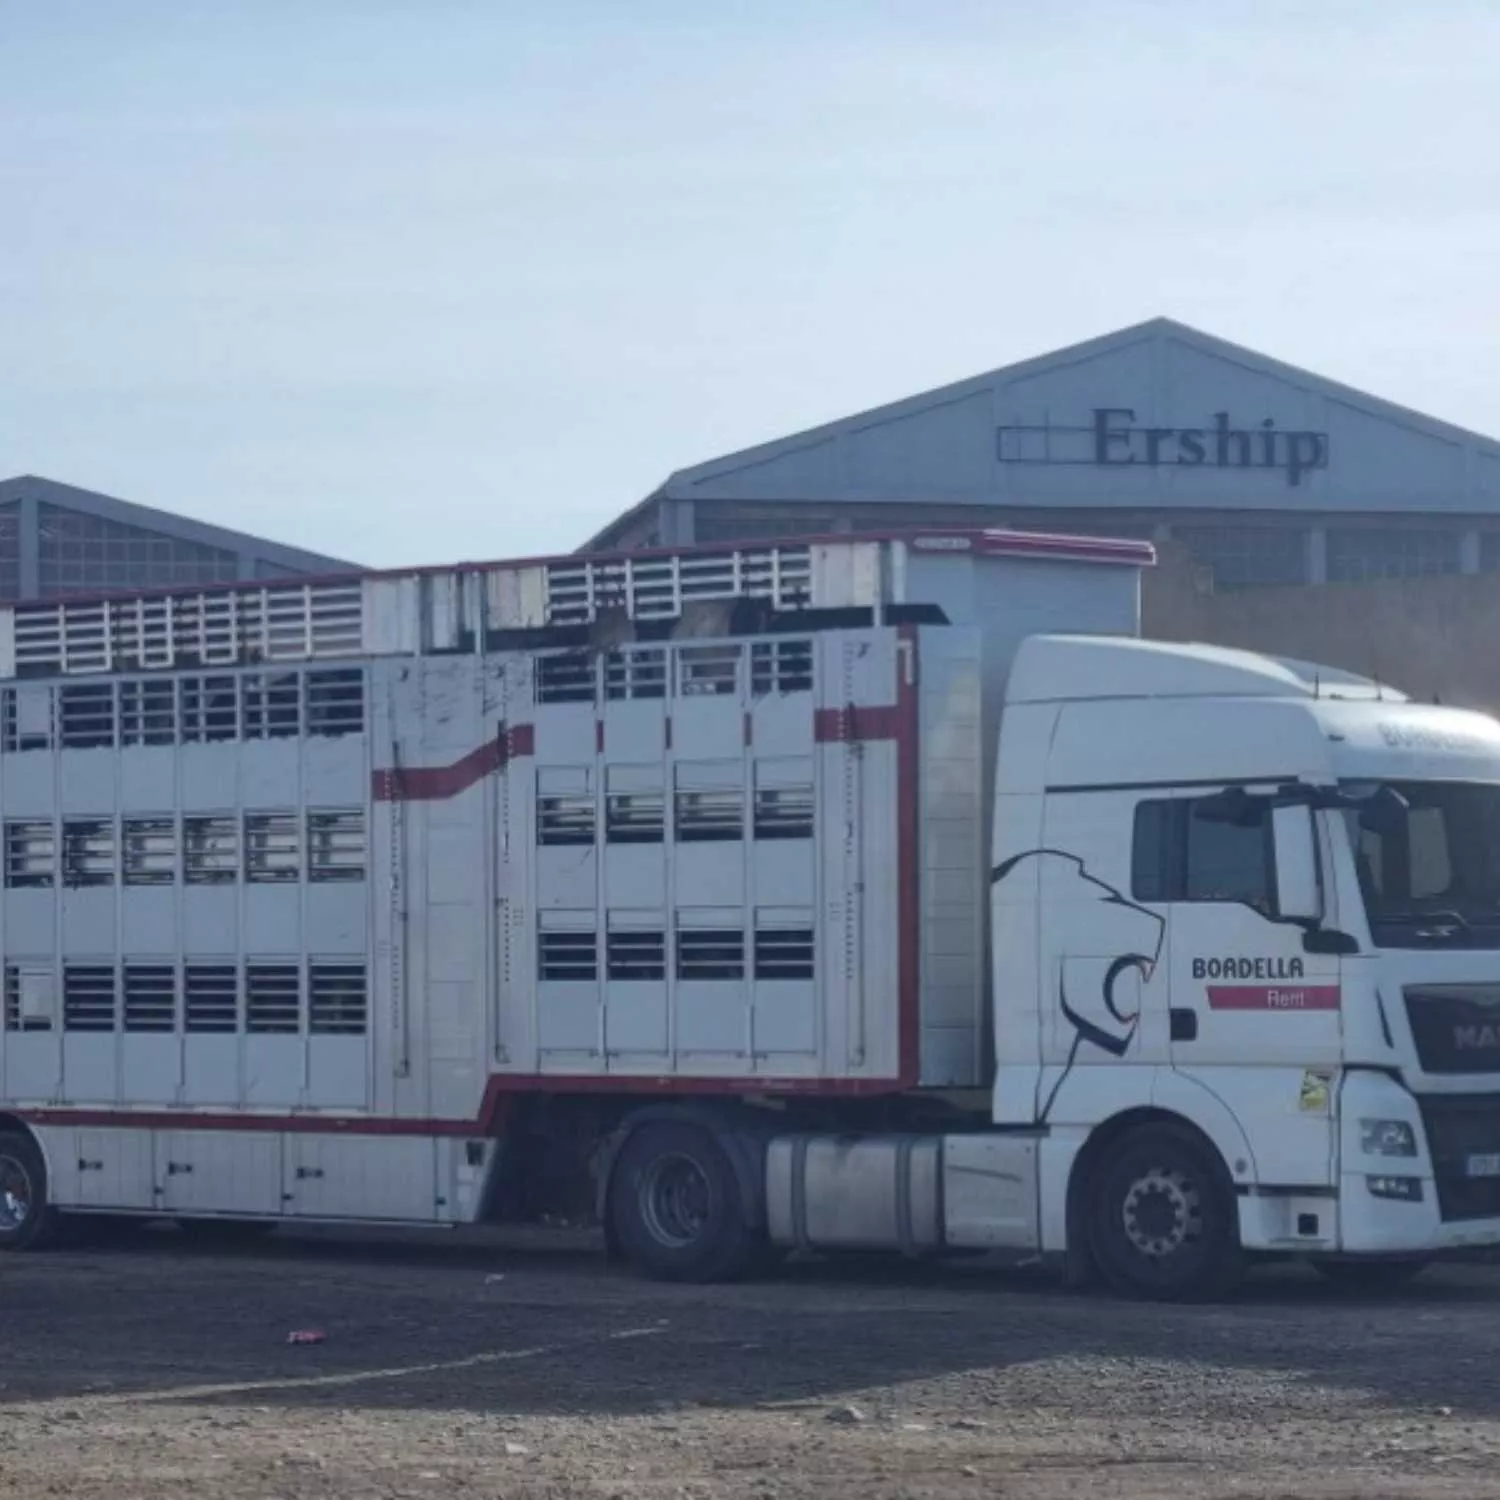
0;0;1500;566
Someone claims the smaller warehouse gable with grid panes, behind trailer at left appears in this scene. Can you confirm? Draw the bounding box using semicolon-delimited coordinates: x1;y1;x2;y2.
0;474;350;603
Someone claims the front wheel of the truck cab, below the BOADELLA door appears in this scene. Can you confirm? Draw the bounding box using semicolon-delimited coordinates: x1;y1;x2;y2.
1086;1124;1245;1302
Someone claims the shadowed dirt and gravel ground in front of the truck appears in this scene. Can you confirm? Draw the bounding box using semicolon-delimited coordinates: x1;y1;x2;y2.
0;1233;1500;1500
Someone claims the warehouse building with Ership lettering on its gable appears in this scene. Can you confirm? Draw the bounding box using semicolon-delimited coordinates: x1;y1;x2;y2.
590;318;1500;591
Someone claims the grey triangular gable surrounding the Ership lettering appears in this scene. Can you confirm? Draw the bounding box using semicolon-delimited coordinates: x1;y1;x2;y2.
591;318;1500;545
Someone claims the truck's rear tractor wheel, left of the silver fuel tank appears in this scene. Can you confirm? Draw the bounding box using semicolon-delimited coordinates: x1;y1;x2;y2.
609;1122;761;1281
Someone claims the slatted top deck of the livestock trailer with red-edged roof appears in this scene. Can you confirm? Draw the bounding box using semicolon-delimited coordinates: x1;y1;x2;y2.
0;528;1155;678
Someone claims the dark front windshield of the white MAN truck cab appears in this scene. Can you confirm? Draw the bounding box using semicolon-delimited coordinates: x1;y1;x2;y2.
1344;782;1500;948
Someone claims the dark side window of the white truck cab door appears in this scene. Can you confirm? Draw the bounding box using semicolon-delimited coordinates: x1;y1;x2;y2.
1131;797;1277;917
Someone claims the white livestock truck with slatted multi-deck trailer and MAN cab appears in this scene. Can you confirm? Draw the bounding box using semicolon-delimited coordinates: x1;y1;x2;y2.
0;531;1500;1298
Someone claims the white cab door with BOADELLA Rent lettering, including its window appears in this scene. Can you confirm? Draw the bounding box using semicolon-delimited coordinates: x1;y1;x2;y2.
1136;794;1343;1184
